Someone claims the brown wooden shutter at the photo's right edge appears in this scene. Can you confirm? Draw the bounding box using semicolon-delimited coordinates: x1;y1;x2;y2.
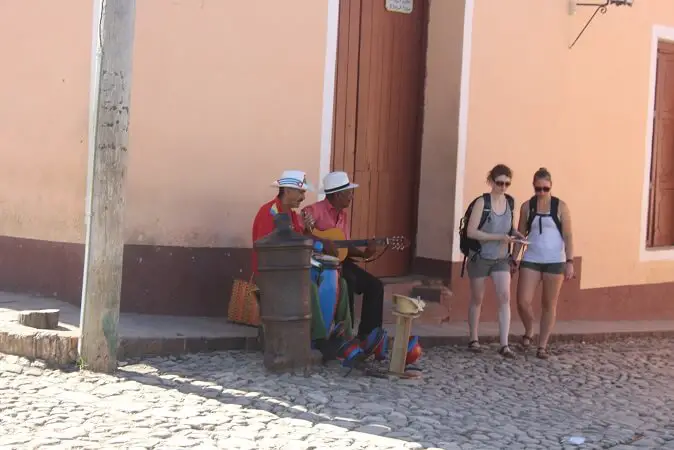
648;43;674;247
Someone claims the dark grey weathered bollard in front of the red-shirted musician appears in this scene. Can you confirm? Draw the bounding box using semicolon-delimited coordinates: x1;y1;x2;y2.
253;214;315;374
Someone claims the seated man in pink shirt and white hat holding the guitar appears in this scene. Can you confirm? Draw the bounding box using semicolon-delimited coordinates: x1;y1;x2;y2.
302;172;384;340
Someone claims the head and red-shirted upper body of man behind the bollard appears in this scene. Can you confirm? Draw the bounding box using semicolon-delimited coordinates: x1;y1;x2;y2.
253;170;314;273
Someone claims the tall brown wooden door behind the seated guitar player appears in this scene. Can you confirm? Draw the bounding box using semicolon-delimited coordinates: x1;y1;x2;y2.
332;0;428;276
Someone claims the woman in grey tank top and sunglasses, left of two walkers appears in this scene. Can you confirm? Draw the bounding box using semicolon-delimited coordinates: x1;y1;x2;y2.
466;164;524;358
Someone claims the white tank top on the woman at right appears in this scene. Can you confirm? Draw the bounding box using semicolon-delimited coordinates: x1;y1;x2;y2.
522;213;566;264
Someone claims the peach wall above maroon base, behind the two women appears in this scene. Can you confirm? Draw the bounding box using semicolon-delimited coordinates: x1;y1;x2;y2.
462;0;674;288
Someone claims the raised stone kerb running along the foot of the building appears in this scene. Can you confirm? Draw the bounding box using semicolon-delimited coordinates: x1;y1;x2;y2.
7;316;674;366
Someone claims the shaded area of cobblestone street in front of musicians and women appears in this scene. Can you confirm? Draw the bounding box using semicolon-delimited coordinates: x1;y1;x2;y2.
90;339;674;449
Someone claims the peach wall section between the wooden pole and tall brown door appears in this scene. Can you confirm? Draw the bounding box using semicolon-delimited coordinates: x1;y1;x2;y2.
127;0;327;247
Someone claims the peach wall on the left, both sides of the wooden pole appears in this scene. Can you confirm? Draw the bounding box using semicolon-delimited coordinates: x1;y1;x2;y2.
0;0;327;246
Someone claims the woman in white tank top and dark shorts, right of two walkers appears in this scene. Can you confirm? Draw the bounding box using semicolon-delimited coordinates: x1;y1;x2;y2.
514;167;574;359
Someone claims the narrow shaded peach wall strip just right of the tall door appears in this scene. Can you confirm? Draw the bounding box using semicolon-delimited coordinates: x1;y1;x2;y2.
416;0;465;261
